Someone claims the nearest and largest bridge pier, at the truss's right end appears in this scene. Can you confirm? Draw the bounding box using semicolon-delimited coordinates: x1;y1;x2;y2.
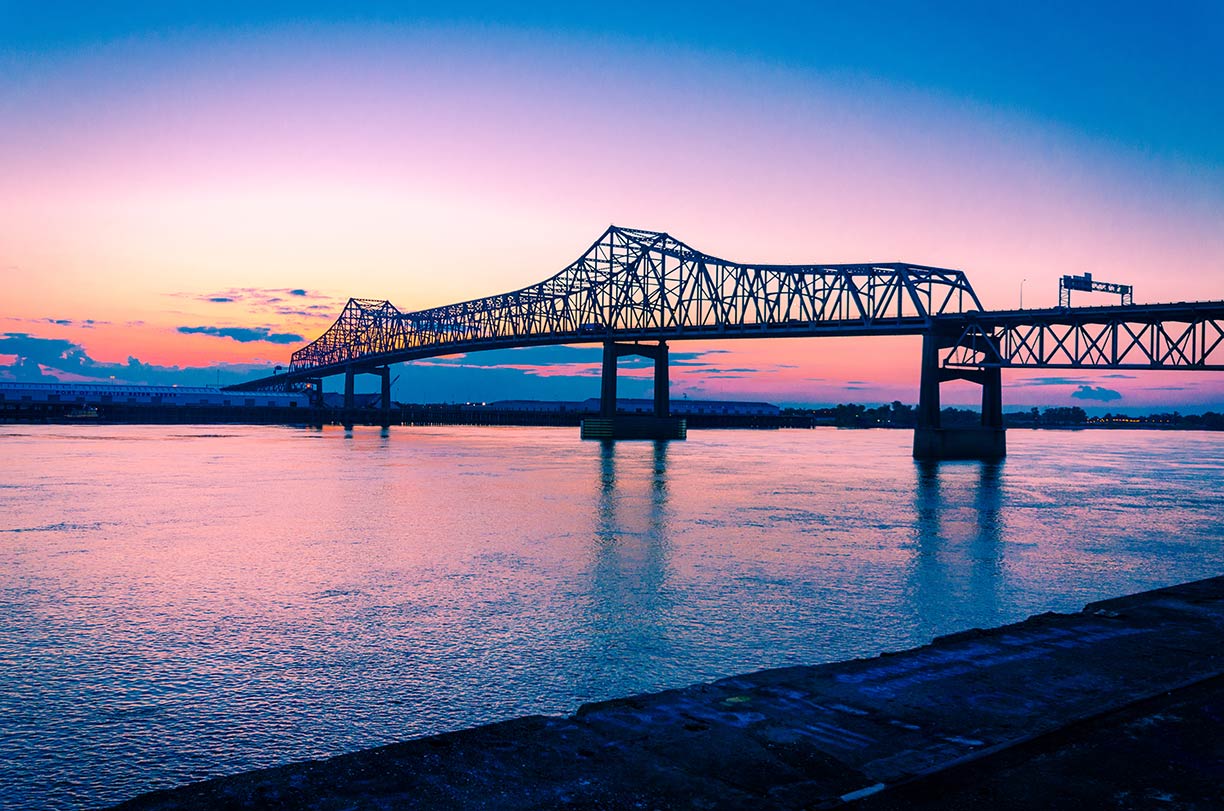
913;331;1007;460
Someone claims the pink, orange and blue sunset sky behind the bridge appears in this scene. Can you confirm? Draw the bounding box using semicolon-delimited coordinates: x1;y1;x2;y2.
0;0;1224;411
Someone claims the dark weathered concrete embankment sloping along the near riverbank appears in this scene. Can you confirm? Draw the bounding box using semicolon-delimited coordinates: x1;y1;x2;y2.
112;577;1224;810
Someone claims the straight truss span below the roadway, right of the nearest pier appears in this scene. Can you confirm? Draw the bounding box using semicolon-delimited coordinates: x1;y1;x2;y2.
944;301;1224;371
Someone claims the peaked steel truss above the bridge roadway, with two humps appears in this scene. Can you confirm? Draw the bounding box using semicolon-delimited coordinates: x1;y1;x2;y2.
284;226;982;378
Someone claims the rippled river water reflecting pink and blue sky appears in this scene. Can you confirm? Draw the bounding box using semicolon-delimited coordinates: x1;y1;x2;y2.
0;426;1224;809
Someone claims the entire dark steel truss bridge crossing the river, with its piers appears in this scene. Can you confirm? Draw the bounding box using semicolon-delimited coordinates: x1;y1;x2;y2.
229;226;1224;459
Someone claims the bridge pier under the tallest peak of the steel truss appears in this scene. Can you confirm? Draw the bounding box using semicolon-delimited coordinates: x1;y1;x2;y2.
581;341;687;439
